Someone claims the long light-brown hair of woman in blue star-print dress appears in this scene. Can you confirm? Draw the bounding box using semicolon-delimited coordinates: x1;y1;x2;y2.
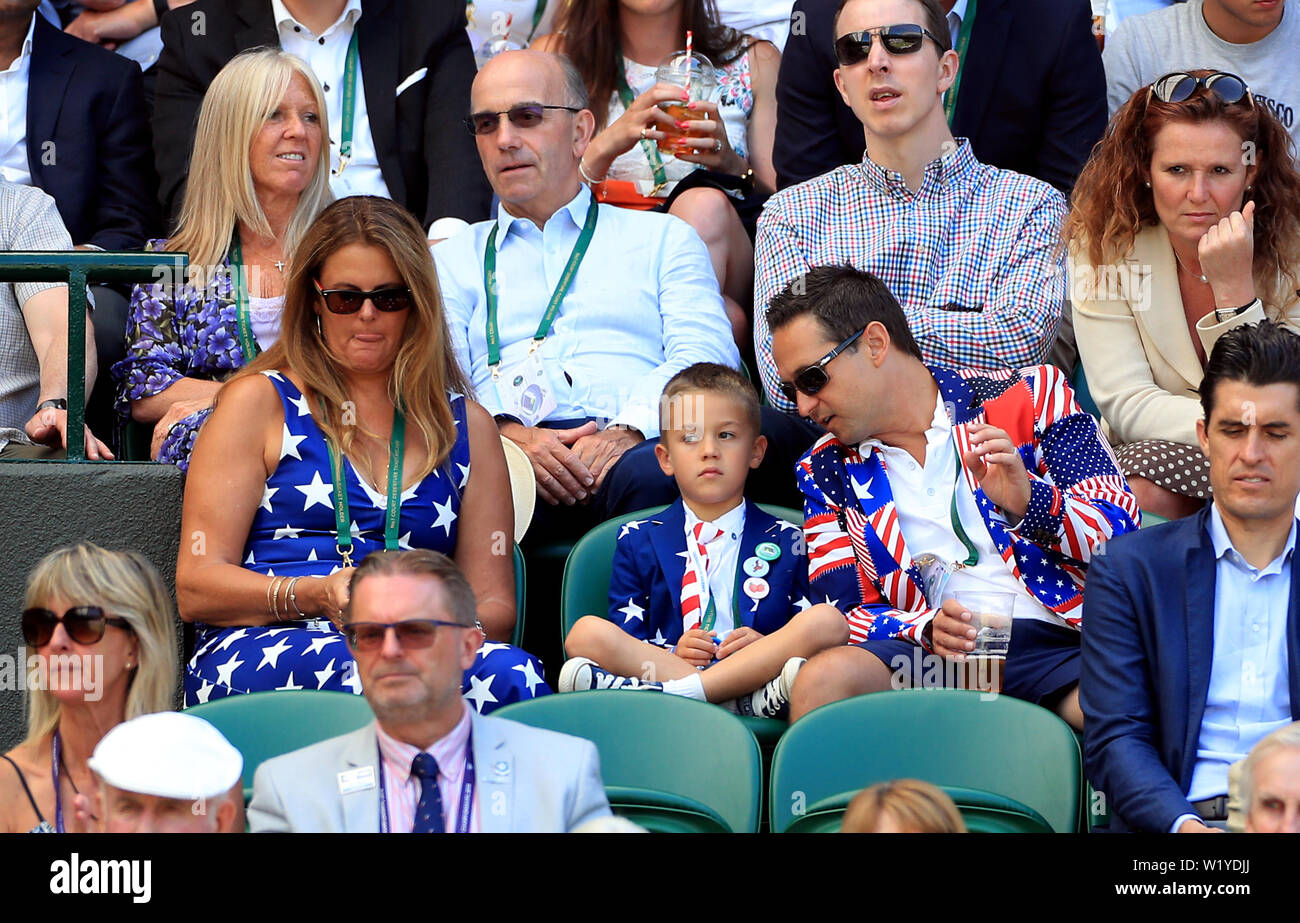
227;195;472;478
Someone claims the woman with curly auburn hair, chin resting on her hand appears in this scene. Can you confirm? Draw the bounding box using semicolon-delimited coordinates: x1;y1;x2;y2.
1065;70;1300;519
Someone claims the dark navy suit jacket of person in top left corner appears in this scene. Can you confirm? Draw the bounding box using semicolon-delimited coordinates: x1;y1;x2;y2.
27;14;157;250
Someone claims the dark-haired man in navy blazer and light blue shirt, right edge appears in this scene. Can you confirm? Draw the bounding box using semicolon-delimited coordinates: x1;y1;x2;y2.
1079;321;1300;833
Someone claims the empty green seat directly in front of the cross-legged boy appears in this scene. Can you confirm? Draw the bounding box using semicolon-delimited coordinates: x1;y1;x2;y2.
497;689;762;833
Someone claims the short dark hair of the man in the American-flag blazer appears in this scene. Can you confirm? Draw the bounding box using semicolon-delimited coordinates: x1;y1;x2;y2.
767;265;922;359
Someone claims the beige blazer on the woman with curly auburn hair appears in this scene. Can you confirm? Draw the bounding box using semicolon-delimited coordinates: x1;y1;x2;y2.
1069;225;1300;446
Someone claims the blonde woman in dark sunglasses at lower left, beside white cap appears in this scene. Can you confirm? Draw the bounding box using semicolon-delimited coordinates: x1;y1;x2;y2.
0;543;177;833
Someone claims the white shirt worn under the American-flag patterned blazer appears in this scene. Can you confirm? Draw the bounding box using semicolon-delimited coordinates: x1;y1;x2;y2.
858;393;1066;627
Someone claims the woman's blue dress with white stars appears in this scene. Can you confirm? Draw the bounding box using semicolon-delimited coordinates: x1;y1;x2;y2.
185;372;551;714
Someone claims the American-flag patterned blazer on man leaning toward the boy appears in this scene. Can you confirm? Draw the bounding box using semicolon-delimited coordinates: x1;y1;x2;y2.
797;365;1139;646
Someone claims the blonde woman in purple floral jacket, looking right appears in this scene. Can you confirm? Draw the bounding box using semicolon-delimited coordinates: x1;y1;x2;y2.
113;48;330;468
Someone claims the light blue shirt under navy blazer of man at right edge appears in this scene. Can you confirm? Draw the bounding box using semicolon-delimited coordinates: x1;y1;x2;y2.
1187;504;1296;801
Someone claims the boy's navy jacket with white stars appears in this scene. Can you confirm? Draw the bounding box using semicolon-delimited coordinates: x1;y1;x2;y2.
610;498;810;647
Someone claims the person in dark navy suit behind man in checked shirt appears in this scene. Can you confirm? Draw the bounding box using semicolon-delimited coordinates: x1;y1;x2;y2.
772;0;1106;194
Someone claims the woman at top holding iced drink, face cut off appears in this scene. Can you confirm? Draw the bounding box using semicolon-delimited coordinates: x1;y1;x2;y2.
533;0;781;348
